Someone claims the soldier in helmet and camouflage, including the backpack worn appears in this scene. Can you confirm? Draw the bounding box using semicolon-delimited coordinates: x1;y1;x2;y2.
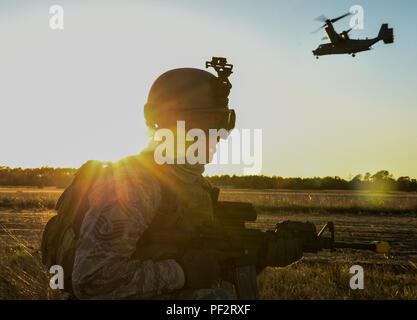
42;58;301;299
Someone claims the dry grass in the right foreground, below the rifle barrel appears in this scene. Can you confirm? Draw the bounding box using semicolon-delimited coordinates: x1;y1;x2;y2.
258;261;417;300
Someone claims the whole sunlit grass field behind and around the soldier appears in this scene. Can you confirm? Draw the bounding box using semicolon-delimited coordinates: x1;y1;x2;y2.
0;188;417;299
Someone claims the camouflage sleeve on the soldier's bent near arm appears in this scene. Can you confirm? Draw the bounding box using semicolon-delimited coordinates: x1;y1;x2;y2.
72;171;185;299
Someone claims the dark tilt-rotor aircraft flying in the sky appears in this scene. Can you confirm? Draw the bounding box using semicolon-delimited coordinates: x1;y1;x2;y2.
312;13;394;59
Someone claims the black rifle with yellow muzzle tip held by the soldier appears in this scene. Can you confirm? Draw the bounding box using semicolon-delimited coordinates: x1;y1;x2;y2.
136;201;390;300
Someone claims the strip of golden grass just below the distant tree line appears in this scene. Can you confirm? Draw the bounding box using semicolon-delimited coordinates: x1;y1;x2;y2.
0;187;417;216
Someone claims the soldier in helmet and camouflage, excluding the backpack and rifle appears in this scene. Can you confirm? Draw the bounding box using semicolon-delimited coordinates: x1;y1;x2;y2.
68;58;235;299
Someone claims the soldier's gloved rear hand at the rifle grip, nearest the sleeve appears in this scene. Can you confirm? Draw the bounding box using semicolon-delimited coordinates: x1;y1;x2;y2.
178;249;220;289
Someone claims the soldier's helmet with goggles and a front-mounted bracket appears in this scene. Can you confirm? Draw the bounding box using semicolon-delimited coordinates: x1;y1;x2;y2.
144;58;235;131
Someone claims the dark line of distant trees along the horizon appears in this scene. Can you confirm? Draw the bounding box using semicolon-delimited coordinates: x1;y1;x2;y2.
0;166;417;191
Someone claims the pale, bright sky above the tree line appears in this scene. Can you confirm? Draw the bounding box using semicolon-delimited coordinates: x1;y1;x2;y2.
0;0;417;178
